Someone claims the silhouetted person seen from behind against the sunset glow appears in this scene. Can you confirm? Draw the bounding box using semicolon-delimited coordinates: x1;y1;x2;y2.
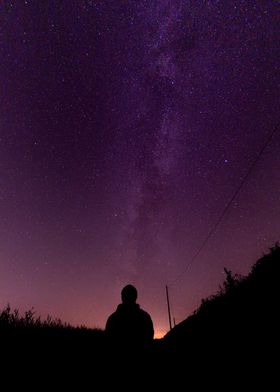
105;285;154;349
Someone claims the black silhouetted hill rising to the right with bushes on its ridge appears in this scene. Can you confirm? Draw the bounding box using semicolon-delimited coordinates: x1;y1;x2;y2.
163;244;280;382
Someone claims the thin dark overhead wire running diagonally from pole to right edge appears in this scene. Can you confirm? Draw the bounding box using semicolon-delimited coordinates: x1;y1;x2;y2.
169;118;280;286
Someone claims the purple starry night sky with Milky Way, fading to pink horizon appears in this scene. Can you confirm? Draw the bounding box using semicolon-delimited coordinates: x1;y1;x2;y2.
0;0;280;336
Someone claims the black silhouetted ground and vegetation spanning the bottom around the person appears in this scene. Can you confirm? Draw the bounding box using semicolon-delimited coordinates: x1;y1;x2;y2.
0;245;280;390
